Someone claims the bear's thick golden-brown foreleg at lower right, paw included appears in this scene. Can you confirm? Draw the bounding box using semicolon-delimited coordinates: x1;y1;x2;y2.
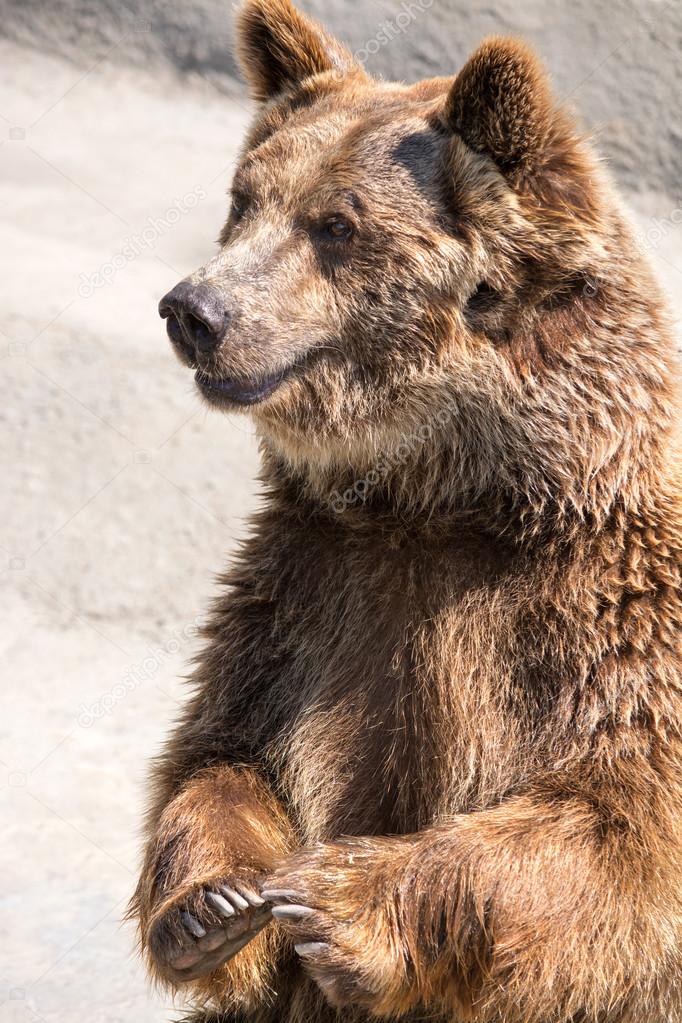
263;773;682;1023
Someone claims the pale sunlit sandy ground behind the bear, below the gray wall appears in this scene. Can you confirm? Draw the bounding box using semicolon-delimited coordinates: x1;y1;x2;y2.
0;21;682;1023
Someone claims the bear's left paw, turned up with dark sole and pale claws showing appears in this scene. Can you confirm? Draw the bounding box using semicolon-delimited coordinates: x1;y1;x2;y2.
148;878;272;984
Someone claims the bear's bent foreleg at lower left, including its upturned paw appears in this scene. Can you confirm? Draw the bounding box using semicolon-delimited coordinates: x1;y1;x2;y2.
130;765;292;1009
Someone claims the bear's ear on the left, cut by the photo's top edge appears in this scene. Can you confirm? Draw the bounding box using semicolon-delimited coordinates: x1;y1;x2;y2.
237;0;357;100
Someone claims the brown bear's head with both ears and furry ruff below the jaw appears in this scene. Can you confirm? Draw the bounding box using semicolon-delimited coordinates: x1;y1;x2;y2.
161;0;670;523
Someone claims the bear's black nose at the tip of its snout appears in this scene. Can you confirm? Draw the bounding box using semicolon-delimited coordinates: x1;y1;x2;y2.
158;280;230;356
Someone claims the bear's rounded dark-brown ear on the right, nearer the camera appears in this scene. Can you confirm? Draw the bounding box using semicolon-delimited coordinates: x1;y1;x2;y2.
445;38;556;182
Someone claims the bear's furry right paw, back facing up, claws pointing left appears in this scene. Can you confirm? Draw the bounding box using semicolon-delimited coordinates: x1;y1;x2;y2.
261;842;413;1016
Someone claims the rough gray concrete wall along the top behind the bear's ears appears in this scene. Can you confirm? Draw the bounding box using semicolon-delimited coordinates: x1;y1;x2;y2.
0;0;682;193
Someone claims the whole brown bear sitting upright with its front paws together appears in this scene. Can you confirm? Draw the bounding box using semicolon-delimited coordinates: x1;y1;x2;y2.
131;0;682;1023
